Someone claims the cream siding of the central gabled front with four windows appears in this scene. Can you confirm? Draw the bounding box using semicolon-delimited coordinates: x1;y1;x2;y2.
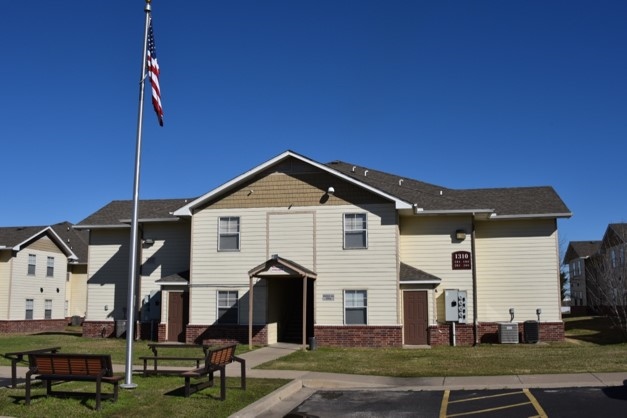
190;204;398;325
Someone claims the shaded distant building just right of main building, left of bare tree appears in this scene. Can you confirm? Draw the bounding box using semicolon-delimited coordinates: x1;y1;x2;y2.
563;241;601;314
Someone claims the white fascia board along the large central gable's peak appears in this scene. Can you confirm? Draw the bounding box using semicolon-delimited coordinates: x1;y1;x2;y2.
173;151;412;216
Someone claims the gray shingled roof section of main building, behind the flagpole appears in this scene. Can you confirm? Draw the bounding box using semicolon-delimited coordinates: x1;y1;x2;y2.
76;198;194;228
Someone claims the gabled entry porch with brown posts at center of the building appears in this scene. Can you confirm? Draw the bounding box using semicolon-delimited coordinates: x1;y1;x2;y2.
248;255;316;347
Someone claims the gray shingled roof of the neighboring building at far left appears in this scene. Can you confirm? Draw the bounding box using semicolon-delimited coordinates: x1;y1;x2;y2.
0;222;87;263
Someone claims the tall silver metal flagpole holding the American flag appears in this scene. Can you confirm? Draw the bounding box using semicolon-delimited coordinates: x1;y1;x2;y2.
120;0;151;389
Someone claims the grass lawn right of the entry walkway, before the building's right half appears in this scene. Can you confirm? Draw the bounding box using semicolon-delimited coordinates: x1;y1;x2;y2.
260;317;627;377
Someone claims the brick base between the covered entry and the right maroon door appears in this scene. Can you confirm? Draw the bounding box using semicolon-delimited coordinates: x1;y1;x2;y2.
314;325;403;347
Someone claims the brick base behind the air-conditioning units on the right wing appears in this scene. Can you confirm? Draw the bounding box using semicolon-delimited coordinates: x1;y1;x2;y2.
428;322;564;346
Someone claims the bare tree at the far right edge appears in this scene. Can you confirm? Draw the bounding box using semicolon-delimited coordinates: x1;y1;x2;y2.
586;250;627;339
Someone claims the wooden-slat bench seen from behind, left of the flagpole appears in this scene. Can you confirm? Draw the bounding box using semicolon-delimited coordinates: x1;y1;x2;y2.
26;353;123;410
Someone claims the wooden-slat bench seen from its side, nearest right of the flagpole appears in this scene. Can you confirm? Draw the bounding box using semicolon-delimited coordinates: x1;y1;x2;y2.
181;344;246;400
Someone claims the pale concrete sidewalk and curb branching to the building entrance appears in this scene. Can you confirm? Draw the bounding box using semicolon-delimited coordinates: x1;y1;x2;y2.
0;344;627;418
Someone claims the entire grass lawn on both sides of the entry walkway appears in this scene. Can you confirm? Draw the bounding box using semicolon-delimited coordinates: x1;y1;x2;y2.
0;317;627;417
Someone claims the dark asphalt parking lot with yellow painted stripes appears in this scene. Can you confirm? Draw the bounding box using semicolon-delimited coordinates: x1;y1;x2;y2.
282;386;627;418
